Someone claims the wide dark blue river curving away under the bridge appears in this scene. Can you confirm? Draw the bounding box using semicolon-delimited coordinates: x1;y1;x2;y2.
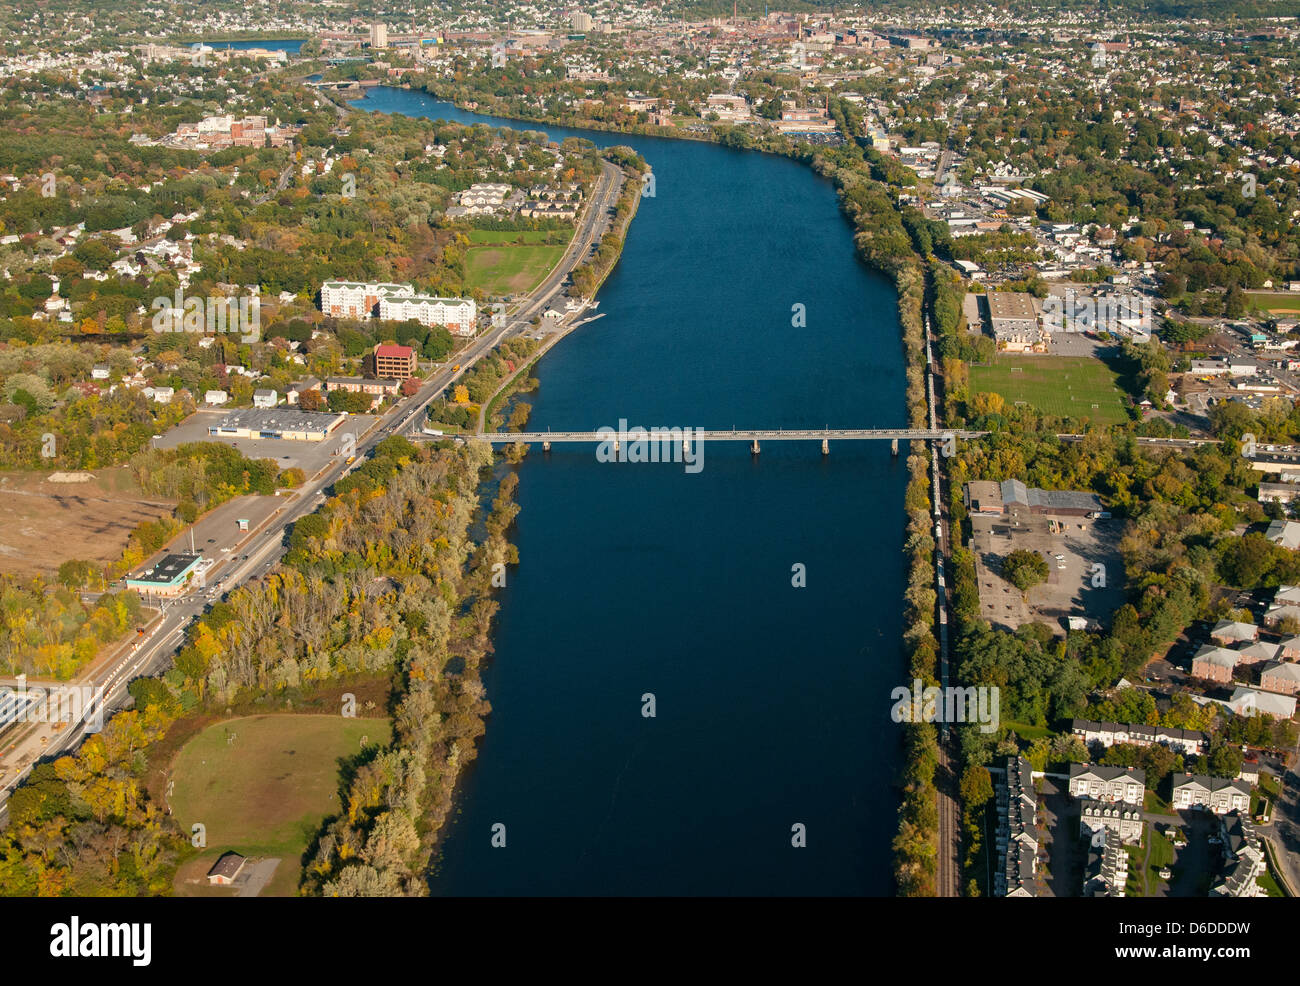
354;88;906;895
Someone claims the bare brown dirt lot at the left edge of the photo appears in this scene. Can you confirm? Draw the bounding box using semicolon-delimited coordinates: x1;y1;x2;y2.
0;468;176;575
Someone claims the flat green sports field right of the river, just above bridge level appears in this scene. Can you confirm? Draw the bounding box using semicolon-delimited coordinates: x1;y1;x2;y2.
970;355;1128;425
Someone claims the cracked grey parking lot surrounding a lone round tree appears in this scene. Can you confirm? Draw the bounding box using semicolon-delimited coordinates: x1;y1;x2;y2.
971;510;1123;635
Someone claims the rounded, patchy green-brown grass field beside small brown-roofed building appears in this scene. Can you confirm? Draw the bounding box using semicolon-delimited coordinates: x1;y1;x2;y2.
168;714;391;896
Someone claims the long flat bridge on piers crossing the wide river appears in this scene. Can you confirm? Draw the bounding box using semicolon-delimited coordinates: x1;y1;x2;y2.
412;427;988;453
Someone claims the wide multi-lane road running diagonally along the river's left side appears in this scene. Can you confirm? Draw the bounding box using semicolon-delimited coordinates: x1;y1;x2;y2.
0;161;624;826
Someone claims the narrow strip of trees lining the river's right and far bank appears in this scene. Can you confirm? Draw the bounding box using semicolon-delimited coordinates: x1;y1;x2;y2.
395;83;961;896
